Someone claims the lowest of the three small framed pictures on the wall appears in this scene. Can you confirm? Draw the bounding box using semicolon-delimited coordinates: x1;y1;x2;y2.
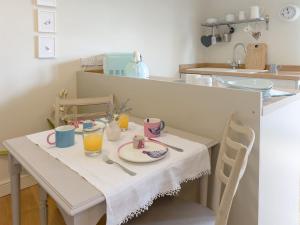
38;36;56;59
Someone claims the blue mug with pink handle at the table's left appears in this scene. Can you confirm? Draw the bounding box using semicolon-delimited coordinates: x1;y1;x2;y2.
47;125;75;148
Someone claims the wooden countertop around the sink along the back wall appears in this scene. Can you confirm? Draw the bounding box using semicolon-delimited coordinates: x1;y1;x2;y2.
179;63;300;81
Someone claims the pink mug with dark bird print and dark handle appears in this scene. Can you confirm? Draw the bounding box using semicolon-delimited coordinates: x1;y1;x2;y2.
144;118;165;138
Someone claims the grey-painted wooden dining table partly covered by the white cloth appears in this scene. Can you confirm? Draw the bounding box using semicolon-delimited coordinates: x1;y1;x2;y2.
3;117;218;225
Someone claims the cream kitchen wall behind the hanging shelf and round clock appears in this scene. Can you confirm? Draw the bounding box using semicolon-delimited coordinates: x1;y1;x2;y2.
202;0;300;65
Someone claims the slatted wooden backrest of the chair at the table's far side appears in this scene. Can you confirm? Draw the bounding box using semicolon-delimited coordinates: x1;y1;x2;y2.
54;95;114;126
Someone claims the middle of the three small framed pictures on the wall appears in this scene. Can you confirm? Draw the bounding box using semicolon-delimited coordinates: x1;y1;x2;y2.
37;10;56;33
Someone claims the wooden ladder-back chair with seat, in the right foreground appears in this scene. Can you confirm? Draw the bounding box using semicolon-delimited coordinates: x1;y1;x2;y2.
128;115;255;225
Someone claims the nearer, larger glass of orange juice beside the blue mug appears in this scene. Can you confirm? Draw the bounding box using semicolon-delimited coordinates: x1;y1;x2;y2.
83;128;103;156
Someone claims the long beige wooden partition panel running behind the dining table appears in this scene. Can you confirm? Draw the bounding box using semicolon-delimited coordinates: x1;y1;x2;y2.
77;72;262;225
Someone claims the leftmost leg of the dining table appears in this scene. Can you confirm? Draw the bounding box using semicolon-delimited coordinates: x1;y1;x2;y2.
9;154;21;225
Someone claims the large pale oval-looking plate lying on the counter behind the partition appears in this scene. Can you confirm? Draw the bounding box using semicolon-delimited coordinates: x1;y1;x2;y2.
225;79;274;91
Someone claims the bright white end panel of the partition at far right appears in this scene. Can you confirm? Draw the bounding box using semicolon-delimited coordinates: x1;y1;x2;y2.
259;99;300;225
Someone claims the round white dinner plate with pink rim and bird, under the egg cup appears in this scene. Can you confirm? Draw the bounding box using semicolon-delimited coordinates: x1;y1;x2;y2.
118;141;168;163
